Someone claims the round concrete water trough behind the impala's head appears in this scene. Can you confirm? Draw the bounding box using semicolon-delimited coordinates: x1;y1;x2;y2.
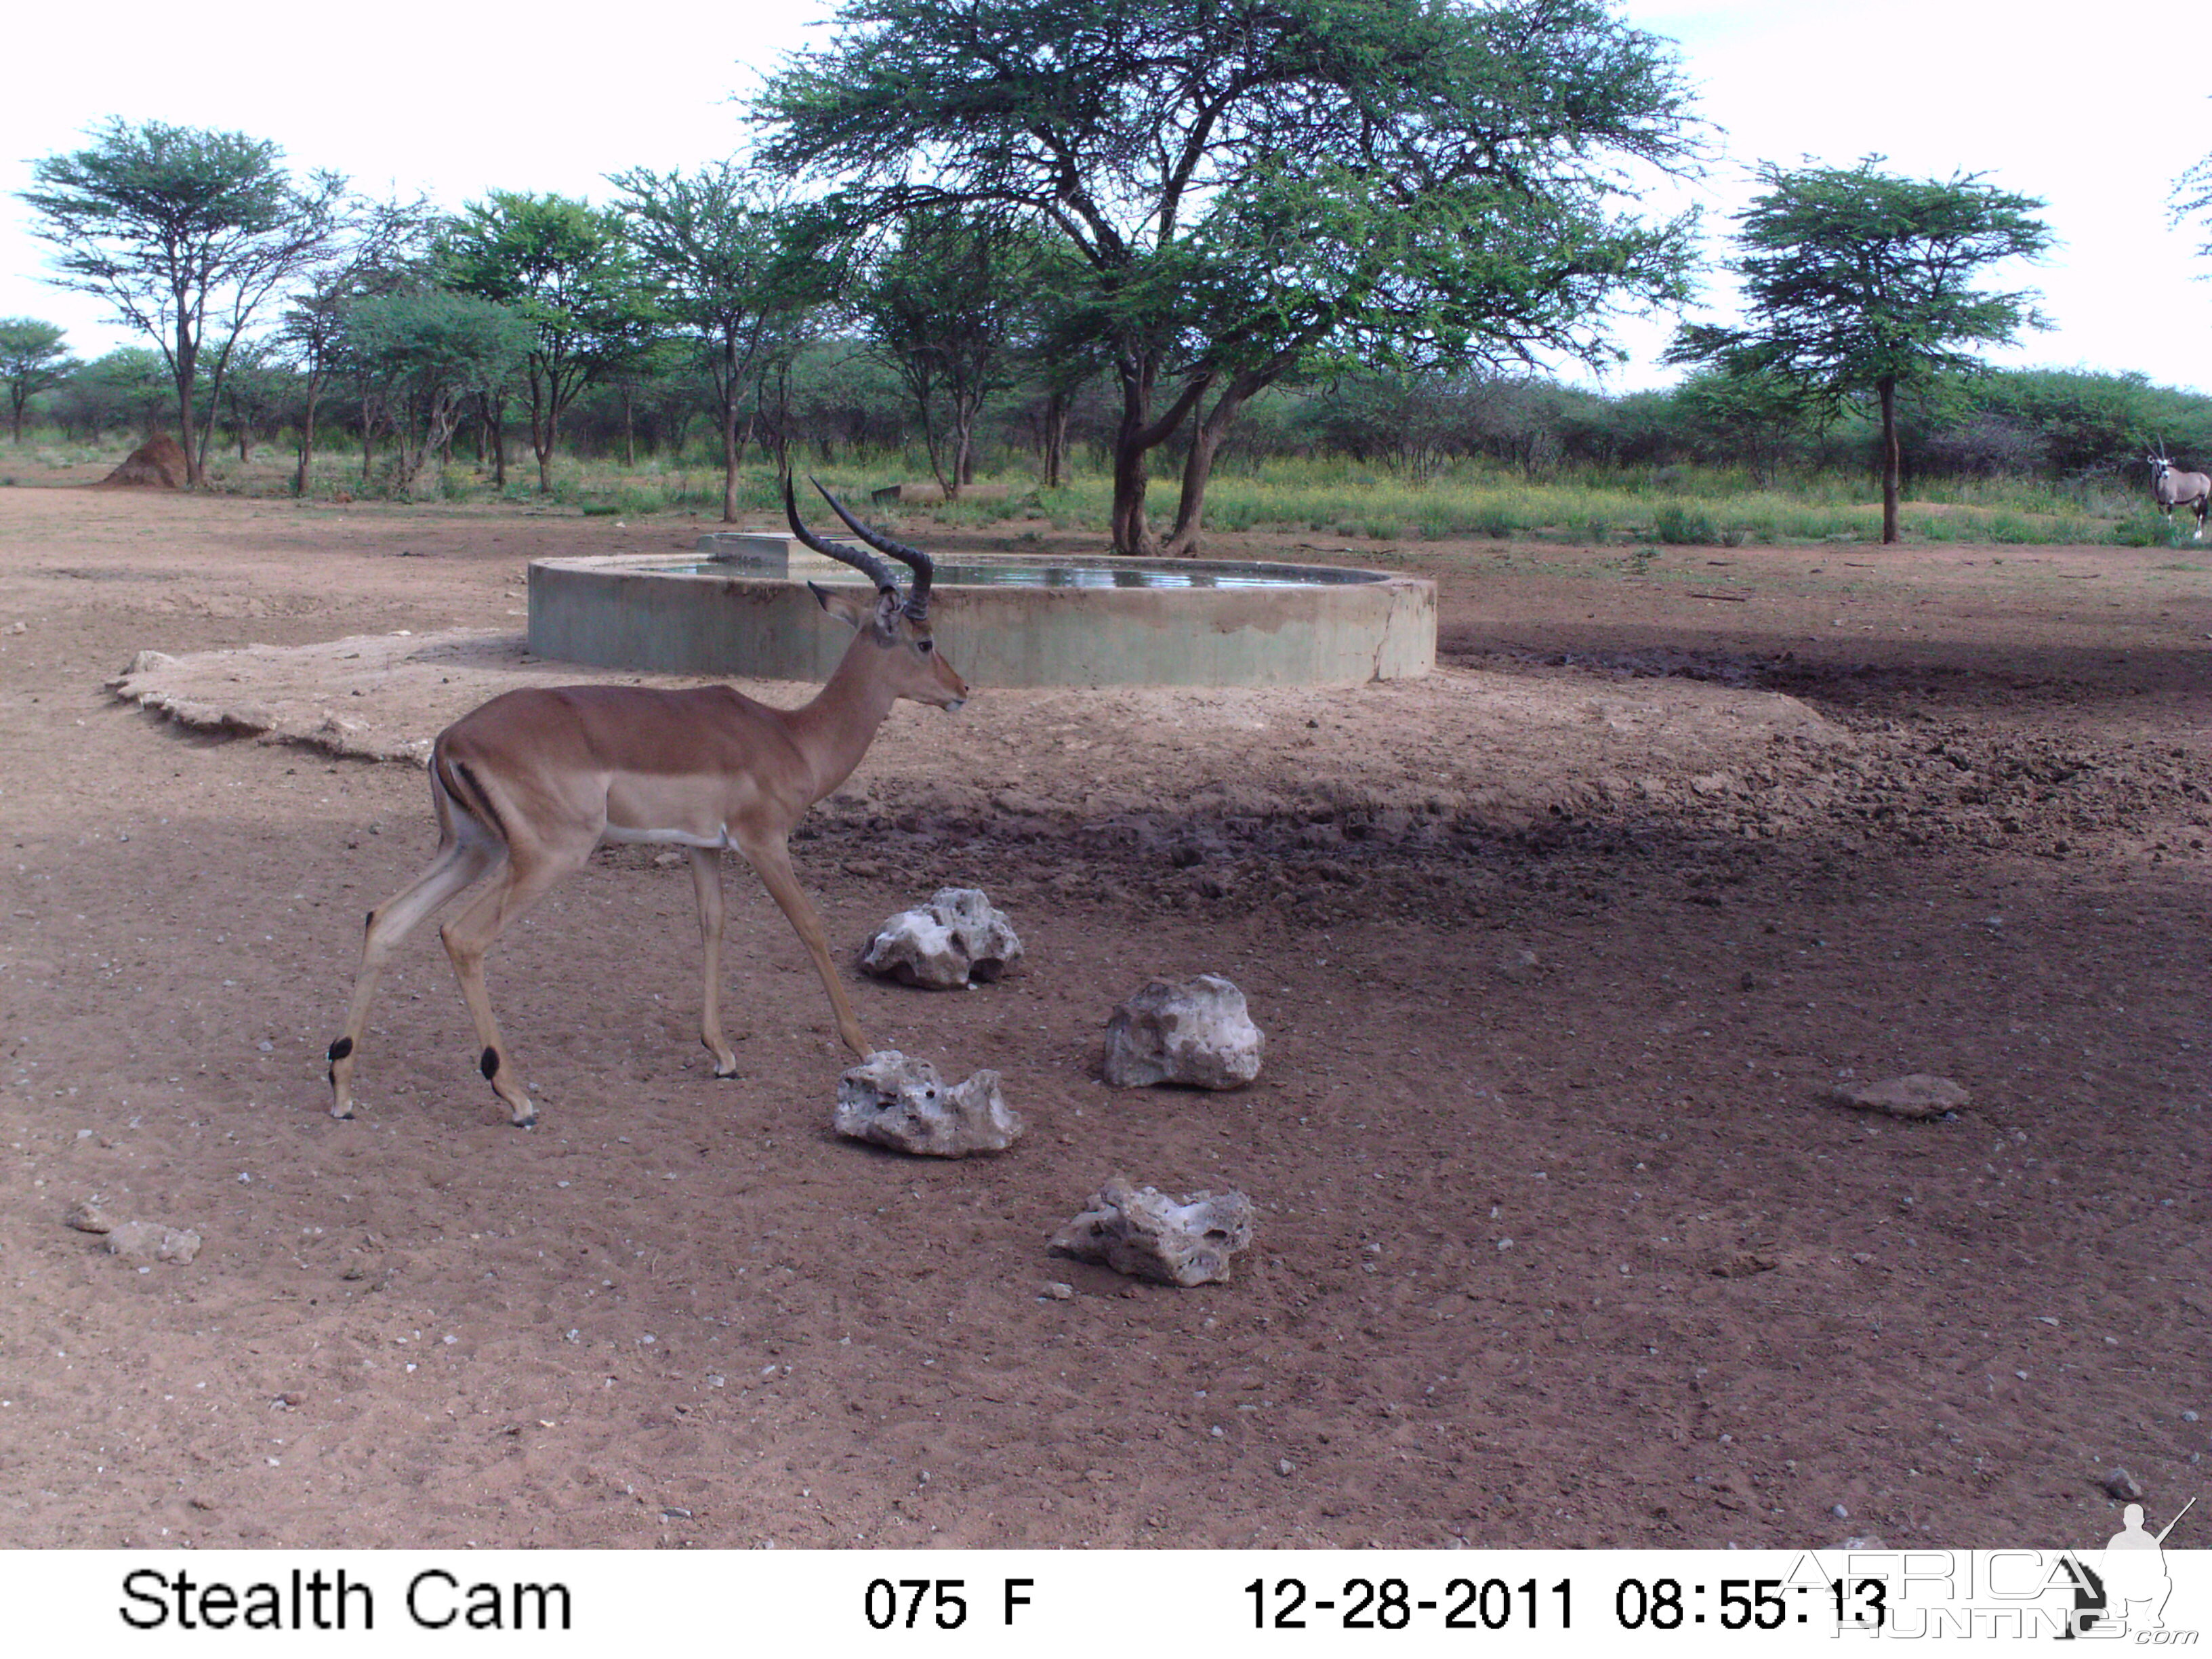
529;555;1435;686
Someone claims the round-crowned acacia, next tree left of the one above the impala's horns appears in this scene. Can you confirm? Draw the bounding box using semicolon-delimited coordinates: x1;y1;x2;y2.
438;190;657;493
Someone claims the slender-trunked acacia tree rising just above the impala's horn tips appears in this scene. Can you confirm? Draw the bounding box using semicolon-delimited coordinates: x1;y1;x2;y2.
609;161;834;525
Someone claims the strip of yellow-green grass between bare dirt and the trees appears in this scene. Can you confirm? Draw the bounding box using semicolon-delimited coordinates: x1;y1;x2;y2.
0;431;2188;546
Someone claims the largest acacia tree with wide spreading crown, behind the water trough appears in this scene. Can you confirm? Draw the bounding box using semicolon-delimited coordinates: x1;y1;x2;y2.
752;0;1694;553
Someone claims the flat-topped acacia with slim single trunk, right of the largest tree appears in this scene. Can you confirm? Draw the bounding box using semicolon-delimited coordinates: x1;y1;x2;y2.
1666;155;2051;542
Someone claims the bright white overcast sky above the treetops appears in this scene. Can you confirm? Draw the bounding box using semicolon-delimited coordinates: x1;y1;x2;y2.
0;0;2212;392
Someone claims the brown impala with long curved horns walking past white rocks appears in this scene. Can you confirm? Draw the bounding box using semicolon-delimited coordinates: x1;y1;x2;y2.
329;483;969;1128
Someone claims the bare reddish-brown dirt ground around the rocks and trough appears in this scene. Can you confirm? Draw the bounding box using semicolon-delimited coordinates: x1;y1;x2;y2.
0;473;2212;1547
